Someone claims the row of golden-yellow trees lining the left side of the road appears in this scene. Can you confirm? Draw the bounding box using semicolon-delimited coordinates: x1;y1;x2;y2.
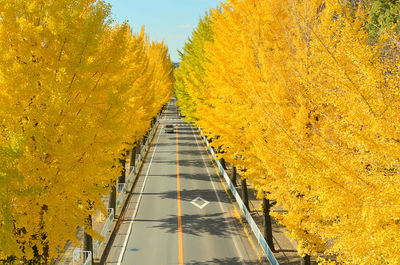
0;0;173;264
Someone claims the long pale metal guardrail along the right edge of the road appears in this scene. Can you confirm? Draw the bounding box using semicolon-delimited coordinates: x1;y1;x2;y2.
198;127;279;265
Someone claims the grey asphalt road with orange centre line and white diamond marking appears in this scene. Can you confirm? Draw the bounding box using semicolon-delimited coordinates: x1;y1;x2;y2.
106;102;262;265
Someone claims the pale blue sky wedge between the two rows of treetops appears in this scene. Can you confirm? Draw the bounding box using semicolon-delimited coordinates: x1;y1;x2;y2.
106;0;220;62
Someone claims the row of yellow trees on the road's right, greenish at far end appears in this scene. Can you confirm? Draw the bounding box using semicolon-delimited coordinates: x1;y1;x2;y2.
175;0;400;265
